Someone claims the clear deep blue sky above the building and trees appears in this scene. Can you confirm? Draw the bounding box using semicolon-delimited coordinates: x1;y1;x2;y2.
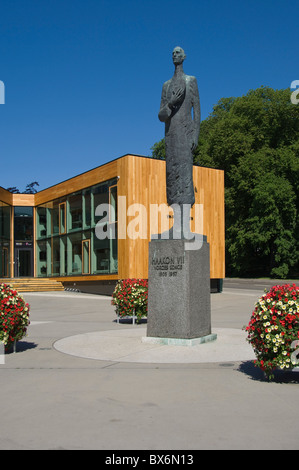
0;0;299;191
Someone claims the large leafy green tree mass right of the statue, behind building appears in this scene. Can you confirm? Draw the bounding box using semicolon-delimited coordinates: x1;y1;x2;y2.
152;87;299;278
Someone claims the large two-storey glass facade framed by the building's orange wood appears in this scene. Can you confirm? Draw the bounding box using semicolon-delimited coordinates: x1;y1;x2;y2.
35;178;118;277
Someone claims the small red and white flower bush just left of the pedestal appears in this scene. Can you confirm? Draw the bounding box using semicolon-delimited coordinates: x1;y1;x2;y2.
111;279;148;322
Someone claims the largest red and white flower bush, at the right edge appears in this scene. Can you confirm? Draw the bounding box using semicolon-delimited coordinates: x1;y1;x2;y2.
246;284;299;379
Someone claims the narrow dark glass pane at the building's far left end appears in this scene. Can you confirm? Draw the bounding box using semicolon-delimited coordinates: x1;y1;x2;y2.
0;201;11;277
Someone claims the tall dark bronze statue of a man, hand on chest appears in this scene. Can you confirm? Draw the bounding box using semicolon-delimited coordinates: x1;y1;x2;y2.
159;47;200;206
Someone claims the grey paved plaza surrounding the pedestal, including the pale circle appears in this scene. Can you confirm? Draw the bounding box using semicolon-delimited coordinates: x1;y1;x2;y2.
0;280;299;450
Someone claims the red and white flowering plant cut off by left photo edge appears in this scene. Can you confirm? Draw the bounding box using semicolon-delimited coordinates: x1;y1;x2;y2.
0;284;30;350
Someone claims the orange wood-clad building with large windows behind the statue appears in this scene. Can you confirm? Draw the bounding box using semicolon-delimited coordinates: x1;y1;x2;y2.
0;155;225;293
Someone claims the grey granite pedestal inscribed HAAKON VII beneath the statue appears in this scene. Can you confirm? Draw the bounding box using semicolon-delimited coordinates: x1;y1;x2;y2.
143;238;216;345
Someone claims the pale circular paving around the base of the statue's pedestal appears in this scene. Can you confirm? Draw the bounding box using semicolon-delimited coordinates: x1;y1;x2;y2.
54;326;255;364
